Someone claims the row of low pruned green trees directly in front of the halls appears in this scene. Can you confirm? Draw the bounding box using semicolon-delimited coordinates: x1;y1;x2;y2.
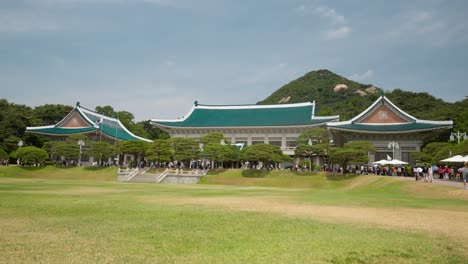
0;125;375;174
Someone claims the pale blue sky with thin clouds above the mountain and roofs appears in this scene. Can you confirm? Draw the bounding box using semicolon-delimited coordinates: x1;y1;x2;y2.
0;0;468;121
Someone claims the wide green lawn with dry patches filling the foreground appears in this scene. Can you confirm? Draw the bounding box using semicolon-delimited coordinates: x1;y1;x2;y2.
0;167;468;263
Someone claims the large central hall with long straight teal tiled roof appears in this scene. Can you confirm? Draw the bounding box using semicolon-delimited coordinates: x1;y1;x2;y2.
151;101;339;155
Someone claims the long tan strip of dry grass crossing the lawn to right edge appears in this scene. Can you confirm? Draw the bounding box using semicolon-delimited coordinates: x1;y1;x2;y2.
153;197;468;244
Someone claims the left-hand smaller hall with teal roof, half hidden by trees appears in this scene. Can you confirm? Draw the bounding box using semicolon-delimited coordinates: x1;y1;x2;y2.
26;102;151;143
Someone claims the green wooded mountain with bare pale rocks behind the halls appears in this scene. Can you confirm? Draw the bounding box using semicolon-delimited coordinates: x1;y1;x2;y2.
258;70;468;132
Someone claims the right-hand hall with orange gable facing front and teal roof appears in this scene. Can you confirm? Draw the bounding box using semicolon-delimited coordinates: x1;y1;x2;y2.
327;94;453;163
